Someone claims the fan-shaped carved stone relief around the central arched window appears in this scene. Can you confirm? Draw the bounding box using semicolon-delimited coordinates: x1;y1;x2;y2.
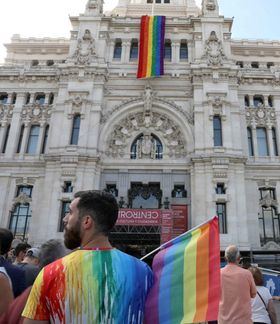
105;112;186;158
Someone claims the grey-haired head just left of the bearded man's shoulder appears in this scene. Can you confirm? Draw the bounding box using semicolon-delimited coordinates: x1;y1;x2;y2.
39;239;67;268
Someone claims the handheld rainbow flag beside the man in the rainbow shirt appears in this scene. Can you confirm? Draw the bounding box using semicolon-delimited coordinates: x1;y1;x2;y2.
145;217;220;324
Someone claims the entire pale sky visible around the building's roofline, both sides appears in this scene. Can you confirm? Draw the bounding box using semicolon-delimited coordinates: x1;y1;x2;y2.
0;0;280;62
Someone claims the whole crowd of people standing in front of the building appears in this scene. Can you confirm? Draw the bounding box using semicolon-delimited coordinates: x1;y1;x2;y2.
0;191;277;324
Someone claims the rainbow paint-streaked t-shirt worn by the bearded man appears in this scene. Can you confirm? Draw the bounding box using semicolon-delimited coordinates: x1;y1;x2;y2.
22;249;153;324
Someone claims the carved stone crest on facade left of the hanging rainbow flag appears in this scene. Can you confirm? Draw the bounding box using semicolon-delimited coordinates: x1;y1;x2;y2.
72;29;97;65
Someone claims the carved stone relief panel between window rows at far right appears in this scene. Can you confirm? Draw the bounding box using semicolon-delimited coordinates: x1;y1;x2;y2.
246;106;276;126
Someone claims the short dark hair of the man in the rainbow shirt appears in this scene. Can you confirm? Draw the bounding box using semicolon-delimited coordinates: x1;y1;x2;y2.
74;190;119;236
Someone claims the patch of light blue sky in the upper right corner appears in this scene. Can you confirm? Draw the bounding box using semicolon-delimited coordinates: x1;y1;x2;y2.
219;0;280;40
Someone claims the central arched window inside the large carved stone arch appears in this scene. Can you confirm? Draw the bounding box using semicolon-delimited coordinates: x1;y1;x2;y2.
130;133;163;160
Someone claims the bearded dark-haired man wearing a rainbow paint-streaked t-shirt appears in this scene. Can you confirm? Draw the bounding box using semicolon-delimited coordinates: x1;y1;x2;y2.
23;191;153;324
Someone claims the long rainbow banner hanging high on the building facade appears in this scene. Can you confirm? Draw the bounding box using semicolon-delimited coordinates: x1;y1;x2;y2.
137;16;165;79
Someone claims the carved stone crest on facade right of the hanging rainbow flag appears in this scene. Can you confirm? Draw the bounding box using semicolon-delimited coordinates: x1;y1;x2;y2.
203;31;226;65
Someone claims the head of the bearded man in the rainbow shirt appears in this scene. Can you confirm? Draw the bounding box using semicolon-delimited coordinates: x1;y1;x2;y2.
63;190;118;250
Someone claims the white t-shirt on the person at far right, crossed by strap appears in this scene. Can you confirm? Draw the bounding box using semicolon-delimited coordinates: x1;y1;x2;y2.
251;286;272;324
